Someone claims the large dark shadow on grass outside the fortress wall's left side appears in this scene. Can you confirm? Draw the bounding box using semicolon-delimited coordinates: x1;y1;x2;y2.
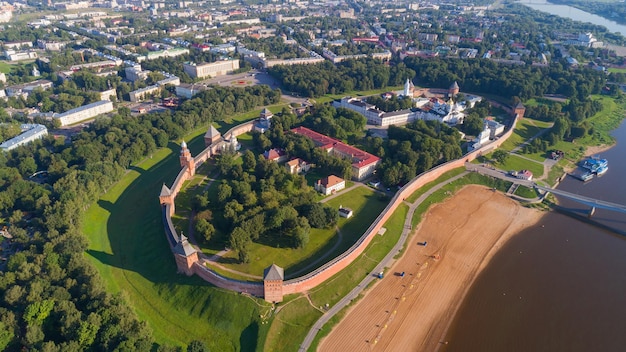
87;136;217;286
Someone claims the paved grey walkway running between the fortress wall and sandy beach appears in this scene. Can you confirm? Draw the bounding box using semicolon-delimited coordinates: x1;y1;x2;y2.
298;171;468;352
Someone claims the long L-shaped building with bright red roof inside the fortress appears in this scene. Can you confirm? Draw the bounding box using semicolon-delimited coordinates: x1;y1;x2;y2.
291;127;380;181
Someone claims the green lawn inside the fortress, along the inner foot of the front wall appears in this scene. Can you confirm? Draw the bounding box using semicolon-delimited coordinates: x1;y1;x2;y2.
216;187;387;277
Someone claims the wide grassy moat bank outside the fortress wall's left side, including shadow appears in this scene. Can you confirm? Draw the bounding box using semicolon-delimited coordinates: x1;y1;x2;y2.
83;109;288;351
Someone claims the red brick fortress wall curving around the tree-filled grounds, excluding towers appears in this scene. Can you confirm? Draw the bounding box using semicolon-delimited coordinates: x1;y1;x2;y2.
164;112;518;297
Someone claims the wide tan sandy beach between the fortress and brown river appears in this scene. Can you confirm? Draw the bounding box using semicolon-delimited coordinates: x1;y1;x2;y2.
319;185;542;352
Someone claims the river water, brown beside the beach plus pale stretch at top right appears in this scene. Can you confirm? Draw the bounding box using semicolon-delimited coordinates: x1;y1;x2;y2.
441;3;626;352
